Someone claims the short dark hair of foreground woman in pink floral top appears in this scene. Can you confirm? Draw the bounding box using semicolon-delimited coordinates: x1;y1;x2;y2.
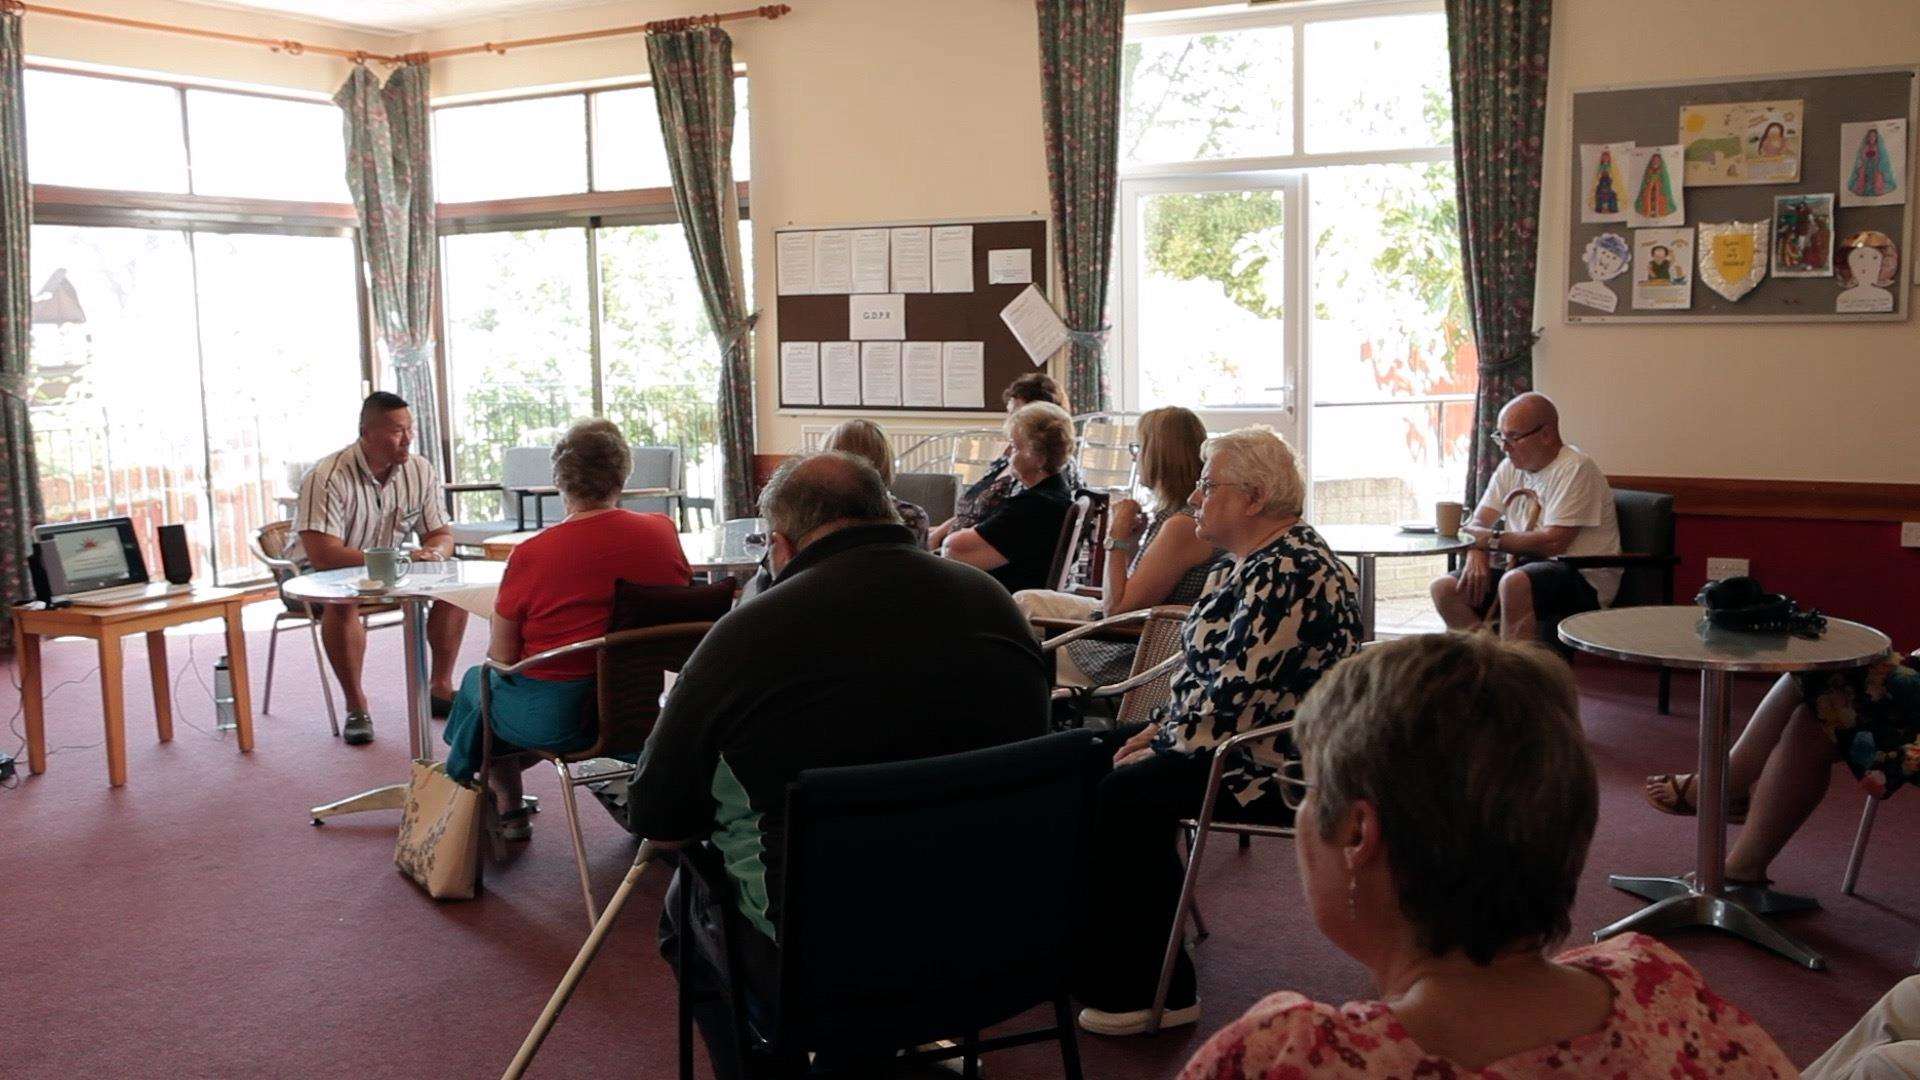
1294;634;1599;965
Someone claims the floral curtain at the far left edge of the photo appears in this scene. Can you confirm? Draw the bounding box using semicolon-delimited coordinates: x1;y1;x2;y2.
0;8;40;653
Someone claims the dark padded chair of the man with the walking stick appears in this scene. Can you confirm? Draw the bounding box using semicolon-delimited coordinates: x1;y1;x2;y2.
680;730;1114;1080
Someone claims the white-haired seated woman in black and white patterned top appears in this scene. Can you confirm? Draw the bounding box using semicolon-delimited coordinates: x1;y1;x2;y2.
1075;427;1361;1036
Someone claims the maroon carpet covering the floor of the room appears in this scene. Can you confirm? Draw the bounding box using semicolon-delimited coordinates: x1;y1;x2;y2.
0;614;1920;1080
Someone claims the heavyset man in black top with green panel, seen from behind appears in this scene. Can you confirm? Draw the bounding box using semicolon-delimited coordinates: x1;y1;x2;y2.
628;454;1048;1076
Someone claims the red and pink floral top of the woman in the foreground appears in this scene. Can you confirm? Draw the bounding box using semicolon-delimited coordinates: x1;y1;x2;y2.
1181;934;1799;1080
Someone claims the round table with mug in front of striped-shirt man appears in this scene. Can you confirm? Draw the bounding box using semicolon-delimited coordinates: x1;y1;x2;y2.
282;559;507;824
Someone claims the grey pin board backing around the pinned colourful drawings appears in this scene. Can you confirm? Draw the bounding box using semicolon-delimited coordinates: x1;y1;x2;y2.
1561;67;1920;323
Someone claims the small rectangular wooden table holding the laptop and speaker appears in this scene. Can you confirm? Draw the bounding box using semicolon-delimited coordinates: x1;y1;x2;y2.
13;584;275;788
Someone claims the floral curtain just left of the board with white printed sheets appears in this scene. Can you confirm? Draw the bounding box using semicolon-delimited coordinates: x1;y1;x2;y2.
647;25;756;517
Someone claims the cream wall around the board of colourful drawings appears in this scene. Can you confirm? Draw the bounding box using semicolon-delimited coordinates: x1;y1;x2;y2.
1534;0;1920;482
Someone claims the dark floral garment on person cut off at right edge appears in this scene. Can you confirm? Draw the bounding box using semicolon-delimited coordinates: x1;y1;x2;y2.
1797;651;1920;798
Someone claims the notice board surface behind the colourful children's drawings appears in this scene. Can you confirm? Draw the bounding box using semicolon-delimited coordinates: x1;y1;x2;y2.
1549;67;1920;323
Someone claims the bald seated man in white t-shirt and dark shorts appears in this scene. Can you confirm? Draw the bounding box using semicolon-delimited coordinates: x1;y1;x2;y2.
1432;394;1620;640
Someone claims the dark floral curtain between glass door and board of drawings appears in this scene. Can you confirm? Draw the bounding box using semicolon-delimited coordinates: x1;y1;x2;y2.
1446;0;1553;505
